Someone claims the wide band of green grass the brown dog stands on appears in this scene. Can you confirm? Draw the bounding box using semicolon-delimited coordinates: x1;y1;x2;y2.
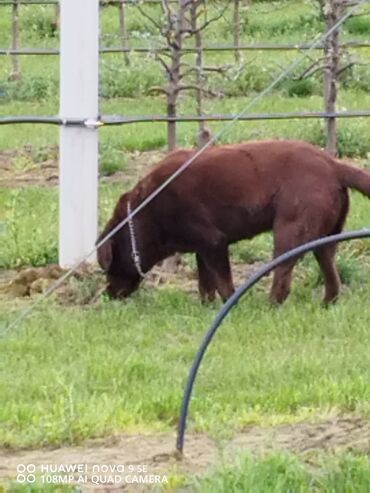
0;185;370;447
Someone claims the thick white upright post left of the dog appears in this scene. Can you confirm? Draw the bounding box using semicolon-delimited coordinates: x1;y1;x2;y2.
59;0;99;267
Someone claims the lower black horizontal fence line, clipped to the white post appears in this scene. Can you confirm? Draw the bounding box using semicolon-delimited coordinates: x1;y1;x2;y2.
0;110;370;127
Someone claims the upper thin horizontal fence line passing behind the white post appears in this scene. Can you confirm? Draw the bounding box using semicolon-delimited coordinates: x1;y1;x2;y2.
0;41;370;55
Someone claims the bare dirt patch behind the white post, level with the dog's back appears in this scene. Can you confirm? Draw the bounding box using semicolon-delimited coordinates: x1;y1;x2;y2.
0;146;165;188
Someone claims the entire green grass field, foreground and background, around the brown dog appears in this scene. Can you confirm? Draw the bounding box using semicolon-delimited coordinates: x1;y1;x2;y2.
0;1;370;493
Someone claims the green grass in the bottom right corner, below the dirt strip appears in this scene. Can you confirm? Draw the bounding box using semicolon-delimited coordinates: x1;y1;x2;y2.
193;454;370;493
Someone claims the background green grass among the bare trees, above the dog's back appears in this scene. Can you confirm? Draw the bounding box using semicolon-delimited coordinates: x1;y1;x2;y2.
0;1;370;158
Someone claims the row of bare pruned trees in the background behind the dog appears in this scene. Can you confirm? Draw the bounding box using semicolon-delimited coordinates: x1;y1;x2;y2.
2;0;368;154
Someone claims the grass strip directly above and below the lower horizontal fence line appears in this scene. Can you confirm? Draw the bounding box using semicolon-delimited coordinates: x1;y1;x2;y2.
0;89;370;155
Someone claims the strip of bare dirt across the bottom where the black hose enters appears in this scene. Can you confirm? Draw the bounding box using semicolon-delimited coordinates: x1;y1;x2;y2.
0;417;370;491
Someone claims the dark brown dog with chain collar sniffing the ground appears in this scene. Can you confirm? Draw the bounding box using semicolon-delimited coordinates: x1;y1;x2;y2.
98;140;370;303
